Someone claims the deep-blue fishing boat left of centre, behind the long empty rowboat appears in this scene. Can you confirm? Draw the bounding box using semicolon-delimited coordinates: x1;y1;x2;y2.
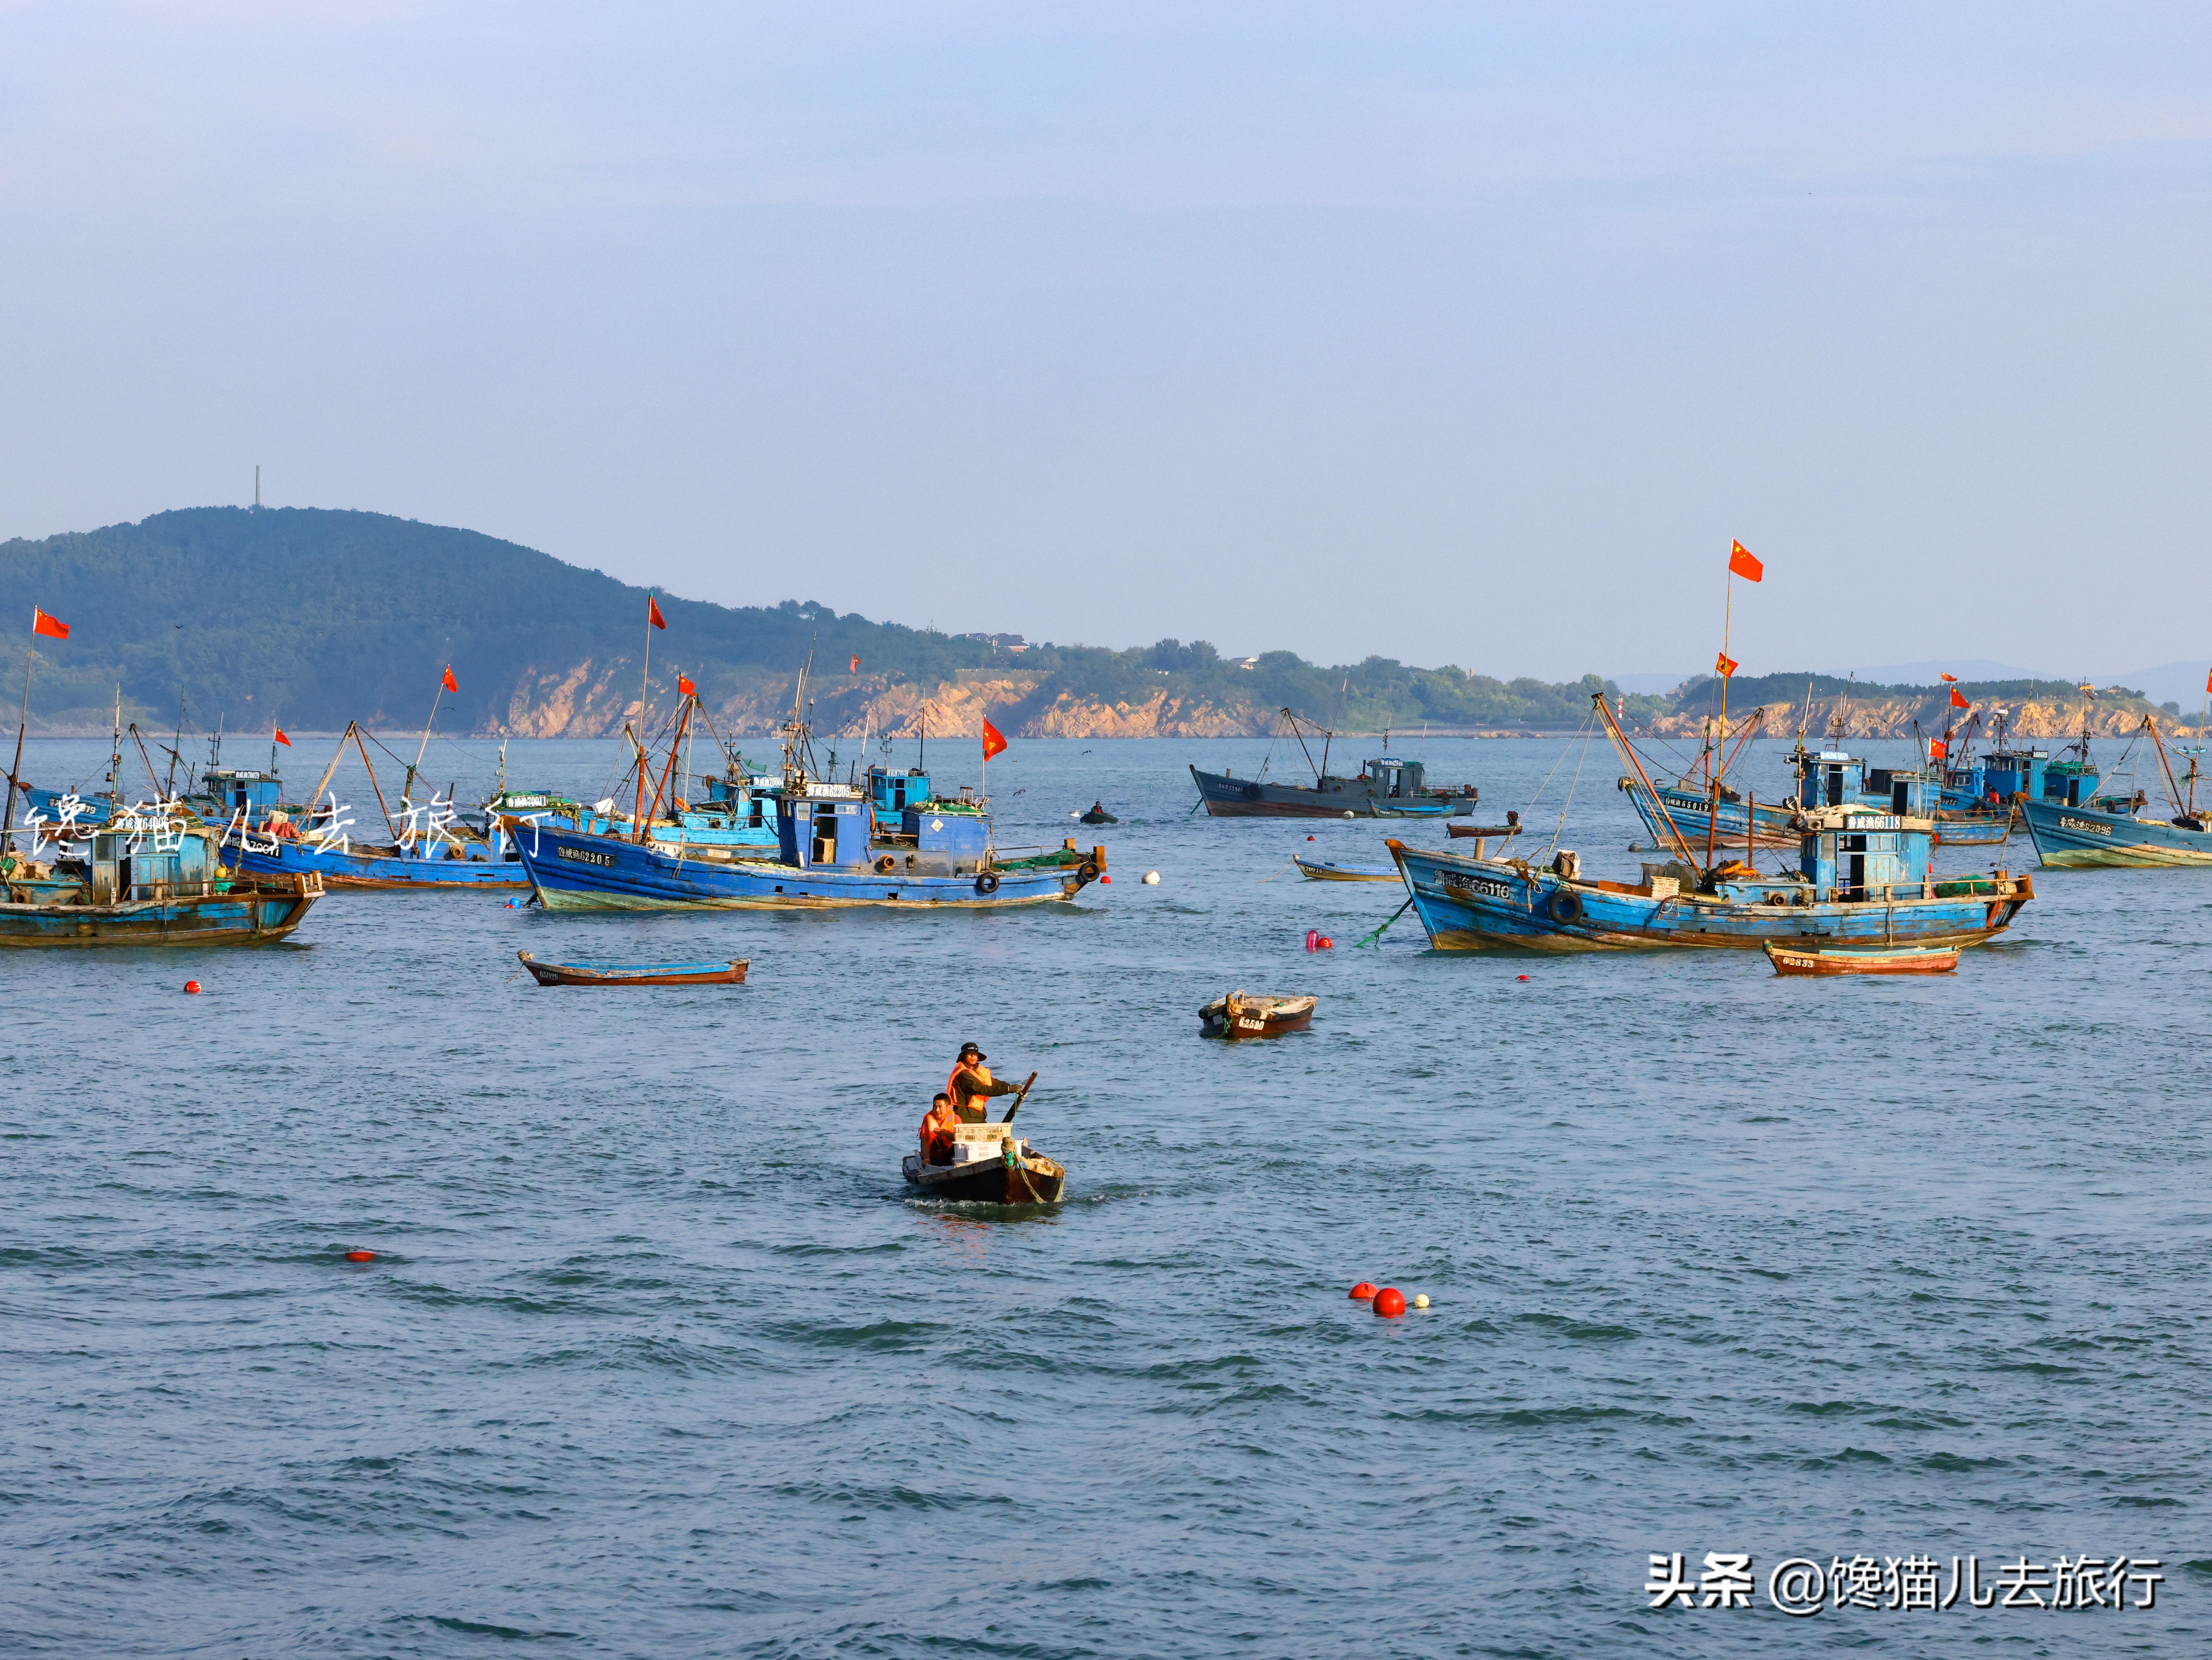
502;703;1106;911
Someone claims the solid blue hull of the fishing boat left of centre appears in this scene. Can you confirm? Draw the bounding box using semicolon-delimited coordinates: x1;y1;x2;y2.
515;829;1095;911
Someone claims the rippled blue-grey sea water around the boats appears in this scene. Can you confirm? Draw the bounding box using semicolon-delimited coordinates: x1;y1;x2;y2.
0;740;2212;1658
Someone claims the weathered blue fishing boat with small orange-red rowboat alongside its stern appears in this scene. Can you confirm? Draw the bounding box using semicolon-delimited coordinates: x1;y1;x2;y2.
1385;698;2035;951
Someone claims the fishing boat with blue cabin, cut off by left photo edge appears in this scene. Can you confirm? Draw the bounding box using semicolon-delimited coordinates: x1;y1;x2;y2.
0;809;323;946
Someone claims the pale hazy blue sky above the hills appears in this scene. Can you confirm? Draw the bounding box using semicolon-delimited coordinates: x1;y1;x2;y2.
0;0;2212;679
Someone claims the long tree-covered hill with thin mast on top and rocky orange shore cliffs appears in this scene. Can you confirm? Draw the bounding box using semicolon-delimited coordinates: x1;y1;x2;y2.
0;508;1670;732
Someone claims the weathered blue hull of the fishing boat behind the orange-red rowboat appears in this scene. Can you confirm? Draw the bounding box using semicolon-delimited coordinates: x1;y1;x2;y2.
1389;842;2035;951
